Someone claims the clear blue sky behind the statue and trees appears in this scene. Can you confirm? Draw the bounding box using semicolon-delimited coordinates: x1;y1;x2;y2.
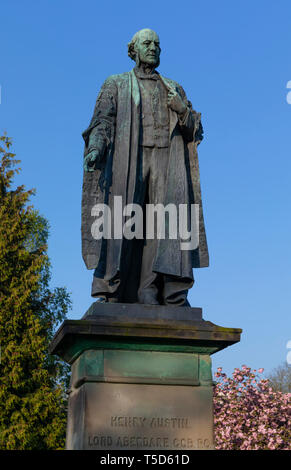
0;0;291;372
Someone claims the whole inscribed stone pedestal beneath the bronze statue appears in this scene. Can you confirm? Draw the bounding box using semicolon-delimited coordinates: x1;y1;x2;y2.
50;303;241;450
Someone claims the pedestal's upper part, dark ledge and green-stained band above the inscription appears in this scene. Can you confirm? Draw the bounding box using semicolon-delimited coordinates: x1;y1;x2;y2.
51;303;241;391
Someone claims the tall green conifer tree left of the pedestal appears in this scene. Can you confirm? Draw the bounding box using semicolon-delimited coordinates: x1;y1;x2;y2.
0;136;70;449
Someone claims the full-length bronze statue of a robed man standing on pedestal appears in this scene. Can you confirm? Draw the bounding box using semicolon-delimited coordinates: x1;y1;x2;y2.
82;29;208;306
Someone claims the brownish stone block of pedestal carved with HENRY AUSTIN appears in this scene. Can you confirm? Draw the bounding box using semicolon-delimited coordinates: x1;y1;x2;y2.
67;383;213;450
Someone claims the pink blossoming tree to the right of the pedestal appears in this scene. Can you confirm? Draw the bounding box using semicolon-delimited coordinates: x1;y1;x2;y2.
214;366;291;450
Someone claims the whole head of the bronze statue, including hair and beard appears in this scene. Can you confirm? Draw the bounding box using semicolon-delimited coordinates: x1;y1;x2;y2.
128;29;161;68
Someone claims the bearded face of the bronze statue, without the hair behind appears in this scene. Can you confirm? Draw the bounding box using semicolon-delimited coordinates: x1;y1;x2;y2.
135;29;161;67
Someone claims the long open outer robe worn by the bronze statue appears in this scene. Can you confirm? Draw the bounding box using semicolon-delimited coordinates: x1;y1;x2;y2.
82;70;209;282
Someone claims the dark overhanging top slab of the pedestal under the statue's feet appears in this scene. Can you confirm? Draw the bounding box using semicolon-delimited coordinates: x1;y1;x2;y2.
50;302;241;363
